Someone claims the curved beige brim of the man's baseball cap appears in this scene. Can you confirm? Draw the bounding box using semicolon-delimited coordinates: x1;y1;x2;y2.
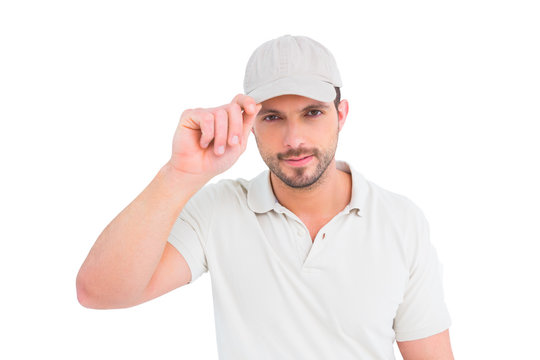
246;77;336;104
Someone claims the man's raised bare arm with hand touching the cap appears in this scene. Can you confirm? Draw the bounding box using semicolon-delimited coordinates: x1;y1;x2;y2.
76;94;261;309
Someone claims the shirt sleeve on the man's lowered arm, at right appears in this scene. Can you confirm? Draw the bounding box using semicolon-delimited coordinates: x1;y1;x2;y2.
394;205;451;341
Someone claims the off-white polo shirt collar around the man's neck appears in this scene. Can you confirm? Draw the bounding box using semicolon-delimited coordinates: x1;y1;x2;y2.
247;160;368;216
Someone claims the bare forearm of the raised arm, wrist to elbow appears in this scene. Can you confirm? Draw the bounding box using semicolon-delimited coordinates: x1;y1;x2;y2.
77;164;205;307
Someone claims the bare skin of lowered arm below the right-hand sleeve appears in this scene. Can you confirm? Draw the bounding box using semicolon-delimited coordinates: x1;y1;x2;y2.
397;329;454;360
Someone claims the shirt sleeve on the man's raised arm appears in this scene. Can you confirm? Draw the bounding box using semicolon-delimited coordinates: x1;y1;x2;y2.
167;184;215;283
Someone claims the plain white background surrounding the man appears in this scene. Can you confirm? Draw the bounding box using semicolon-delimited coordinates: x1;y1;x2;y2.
0;0;540;359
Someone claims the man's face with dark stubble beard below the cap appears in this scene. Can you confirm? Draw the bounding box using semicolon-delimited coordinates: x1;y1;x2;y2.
253;95;348;188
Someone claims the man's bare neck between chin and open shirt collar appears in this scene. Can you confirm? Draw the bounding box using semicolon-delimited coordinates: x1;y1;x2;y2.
270;160;352;218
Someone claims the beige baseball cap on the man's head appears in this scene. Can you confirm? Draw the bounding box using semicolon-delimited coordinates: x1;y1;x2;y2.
244;35;342;103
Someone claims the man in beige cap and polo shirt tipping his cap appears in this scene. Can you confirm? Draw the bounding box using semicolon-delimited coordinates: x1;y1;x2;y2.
77;35;453;360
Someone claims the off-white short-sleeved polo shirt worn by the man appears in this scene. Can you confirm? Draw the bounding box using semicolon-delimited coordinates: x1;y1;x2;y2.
168;162;451;360
